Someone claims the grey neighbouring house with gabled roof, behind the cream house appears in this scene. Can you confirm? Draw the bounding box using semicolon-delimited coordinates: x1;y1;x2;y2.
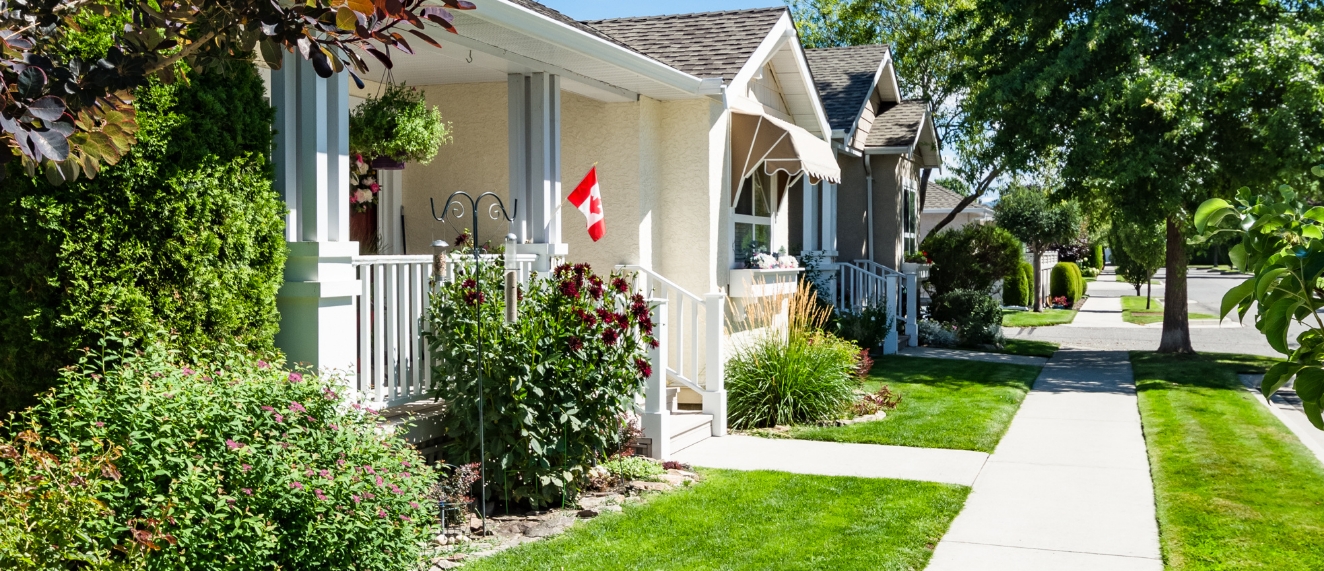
792;45;943;270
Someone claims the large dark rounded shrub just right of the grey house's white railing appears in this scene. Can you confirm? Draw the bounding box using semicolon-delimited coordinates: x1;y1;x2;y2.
920;224;1023;297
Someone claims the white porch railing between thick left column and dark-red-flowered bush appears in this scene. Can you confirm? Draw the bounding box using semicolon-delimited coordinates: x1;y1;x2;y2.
354;256;433;408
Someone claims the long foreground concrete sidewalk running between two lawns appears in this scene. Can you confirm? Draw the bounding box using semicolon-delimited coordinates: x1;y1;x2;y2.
928;348;1162;571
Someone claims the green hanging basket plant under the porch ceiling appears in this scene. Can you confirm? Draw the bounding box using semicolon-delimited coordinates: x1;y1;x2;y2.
350;83;450;168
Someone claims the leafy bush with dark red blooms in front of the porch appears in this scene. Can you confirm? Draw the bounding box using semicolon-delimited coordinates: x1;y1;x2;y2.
429;261;661;506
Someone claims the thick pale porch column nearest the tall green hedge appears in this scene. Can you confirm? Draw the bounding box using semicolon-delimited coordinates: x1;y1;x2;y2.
271;53;360;374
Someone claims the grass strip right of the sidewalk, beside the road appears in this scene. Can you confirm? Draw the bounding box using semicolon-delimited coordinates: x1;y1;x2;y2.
1131;352;1324;571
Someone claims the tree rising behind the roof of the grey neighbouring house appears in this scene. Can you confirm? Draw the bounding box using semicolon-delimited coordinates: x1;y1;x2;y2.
789;0;1002;234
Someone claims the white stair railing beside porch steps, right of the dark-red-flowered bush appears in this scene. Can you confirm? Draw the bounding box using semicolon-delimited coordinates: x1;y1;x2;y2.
616;265;727;457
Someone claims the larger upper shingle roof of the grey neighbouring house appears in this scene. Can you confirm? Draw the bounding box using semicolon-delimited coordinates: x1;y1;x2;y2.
805;45;888;130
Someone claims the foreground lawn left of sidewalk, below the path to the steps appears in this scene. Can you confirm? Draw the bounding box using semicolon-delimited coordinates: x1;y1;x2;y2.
465;470;969;571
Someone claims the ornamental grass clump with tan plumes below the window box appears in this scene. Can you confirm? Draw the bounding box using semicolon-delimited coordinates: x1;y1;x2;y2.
726;287;861;428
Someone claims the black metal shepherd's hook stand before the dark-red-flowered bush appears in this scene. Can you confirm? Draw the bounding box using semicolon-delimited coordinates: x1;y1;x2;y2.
428;191;519;533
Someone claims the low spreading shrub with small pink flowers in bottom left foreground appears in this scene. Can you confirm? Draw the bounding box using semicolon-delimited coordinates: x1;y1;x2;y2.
9;343;437;570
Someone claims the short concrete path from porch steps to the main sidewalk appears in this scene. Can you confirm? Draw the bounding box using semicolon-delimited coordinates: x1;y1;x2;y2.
673;435;989;486
